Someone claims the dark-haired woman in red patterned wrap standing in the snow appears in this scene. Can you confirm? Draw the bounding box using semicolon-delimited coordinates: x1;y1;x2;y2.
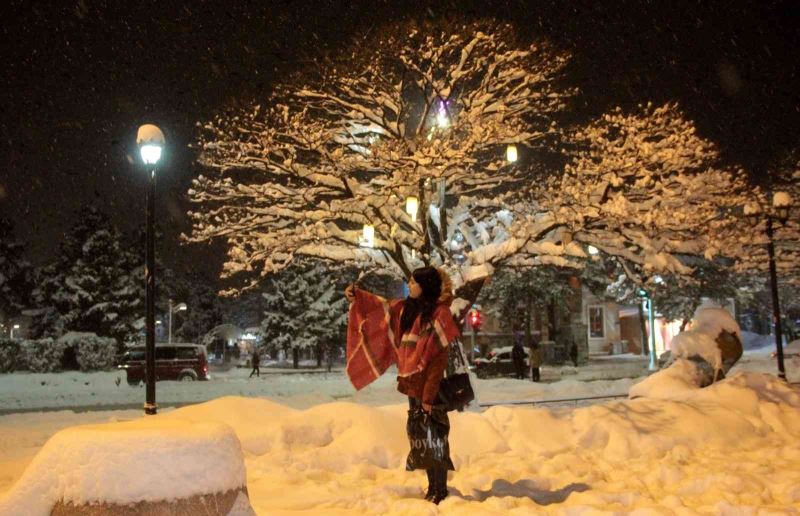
345;267;459;504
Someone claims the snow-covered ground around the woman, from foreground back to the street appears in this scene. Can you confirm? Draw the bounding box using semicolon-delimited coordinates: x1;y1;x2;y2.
0;350;800;514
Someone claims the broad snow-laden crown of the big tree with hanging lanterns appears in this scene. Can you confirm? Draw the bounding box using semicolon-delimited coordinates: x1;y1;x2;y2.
189;22;582;306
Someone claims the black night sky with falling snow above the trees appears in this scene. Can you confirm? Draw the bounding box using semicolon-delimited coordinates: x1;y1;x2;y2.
0;0;800;278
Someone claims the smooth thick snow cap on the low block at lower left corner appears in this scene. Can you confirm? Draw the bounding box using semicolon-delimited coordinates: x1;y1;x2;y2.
0;416;246;516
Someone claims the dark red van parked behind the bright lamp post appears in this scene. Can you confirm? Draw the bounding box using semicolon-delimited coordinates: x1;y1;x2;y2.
118;344;210;385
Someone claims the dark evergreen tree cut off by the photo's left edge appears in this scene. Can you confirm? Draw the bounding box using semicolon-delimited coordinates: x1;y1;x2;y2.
0;217;33;327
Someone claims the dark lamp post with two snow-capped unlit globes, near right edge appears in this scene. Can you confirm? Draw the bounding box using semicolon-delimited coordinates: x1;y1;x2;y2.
744;192;792;380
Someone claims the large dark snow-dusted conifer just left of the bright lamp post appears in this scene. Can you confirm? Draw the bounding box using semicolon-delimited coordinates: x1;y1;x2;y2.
34;208;144;344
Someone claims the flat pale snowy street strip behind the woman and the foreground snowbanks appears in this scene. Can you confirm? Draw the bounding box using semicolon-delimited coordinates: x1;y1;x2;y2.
0;355;647;414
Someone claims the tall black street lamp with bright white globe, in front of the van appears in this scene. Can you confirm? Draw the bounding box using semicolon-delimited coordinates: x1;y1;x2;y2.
136;124;165;415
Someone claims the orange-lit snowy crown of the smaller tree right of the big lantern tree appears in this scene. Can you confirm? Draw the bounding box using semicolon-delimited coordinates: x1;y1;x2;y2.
538;104;748;283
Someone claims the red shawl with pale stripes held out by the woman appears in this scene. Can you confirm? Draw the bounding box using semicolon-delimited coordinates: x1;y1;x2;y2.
345;288;460;390
